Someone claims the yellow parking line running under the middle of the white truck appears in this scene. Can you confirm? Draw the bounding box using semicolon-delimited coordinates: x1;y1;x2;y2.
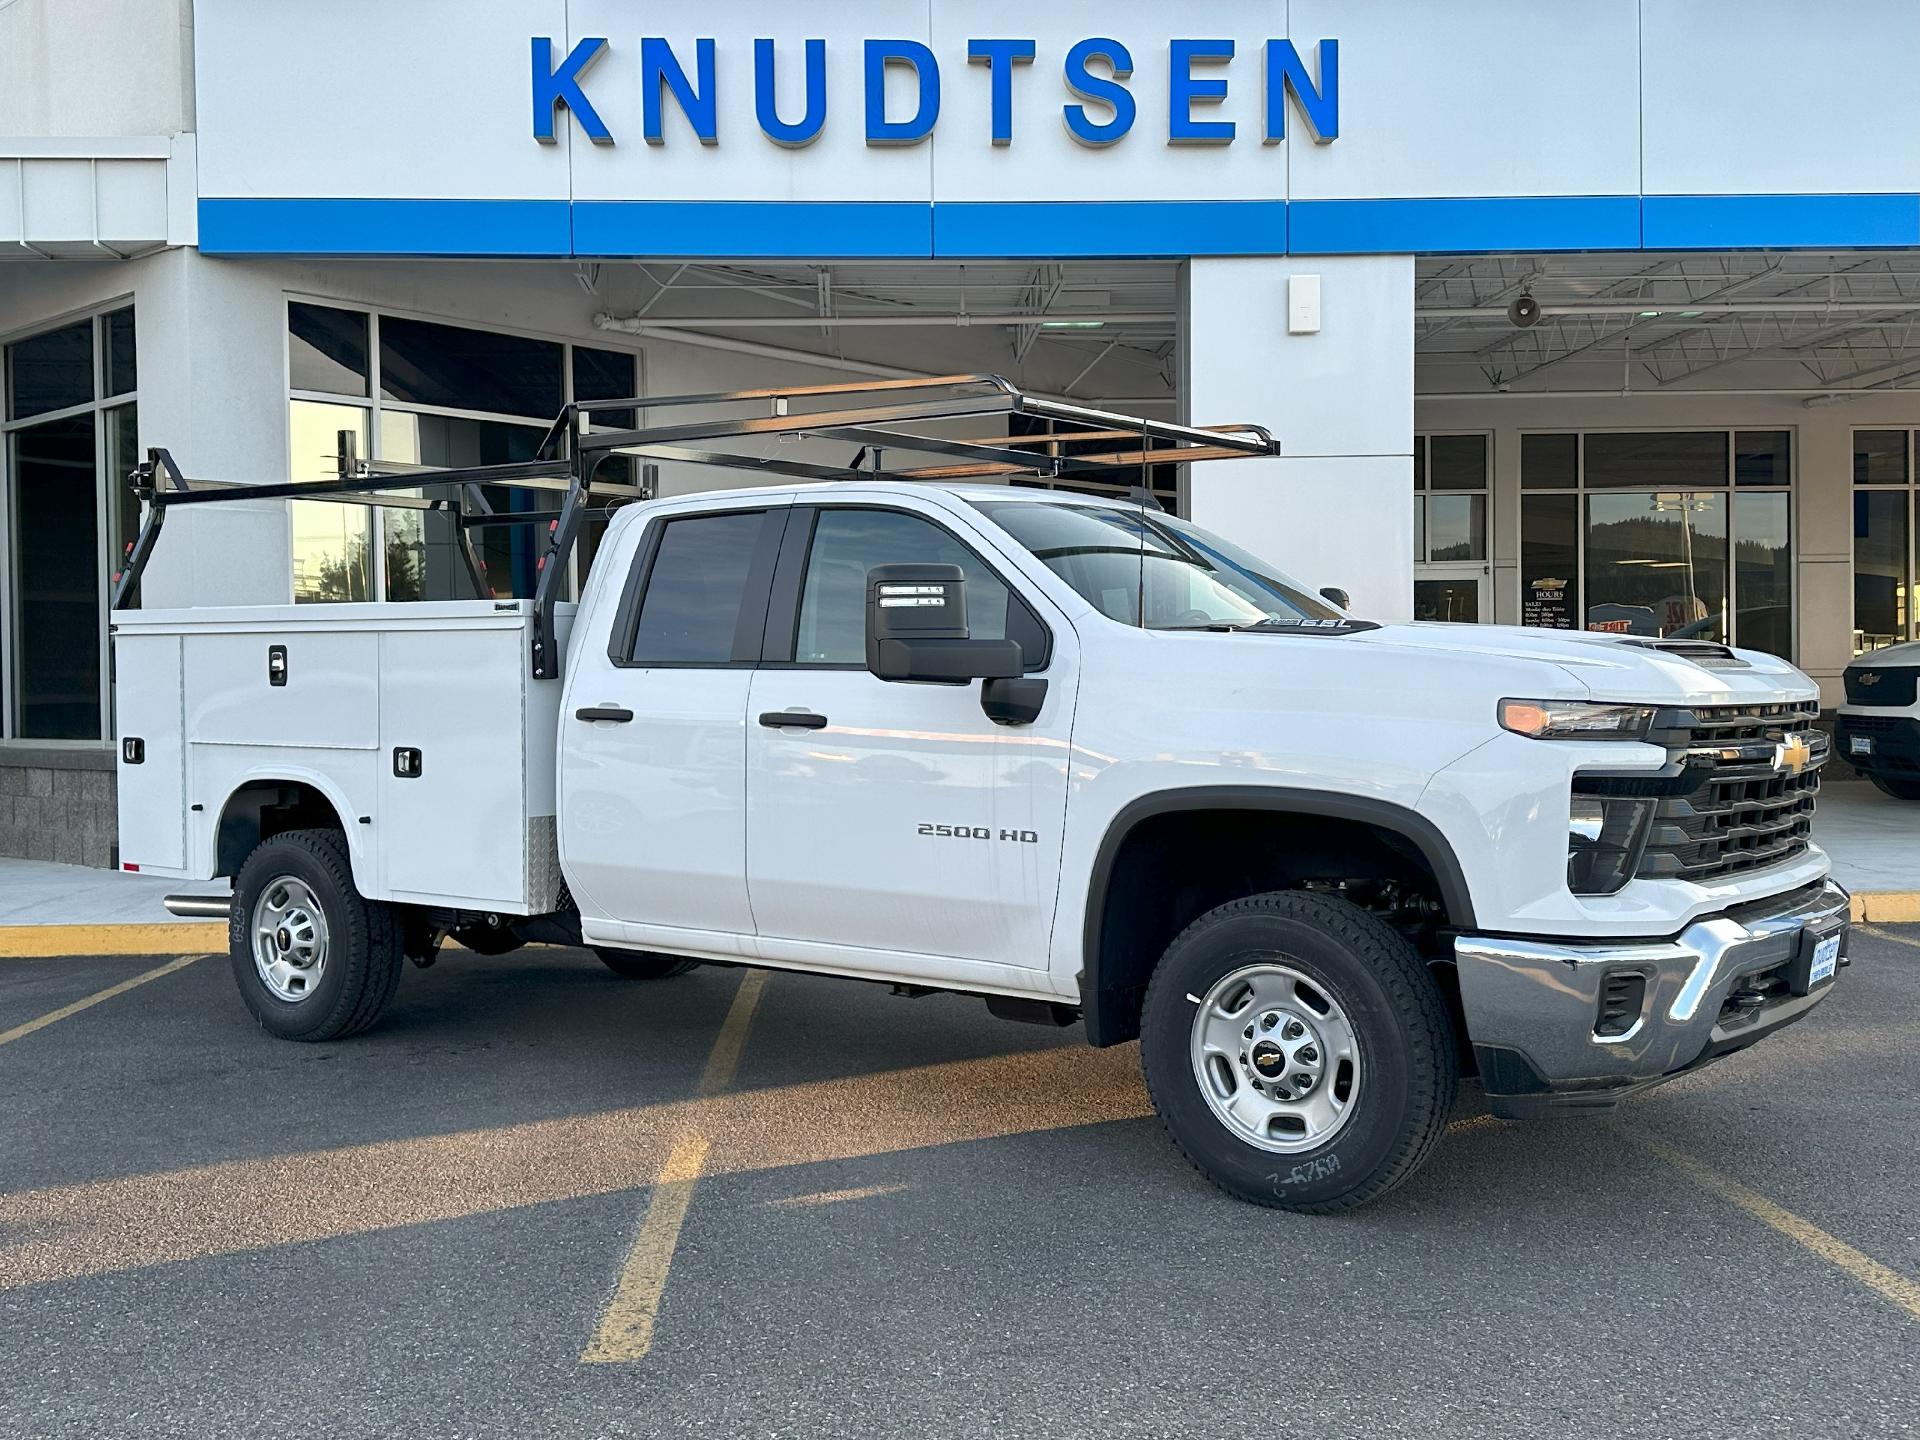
580;970;766;1365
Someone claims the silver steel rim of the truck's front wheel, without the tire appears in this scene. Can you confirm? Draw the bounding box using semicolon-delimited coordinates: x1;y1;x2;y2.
1192;964;1359;1154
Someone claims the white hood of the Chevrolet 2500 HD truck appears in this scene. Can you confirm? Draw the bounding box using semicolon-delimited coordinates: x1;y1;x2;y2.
1346;622;1820;705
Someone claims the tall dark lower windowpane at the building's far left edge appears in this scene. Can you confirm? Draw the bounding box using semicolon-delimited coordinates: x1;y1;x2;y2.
10;410;100;739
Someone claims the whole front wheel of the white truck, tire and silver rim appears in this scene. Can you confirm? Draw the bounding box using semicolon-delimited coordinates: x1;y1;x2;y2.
1140;891;1459;1213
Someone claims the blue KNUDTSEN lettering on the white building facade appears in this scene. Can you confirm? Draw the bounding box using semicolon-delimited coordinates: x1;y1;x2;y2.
532;35;1340;148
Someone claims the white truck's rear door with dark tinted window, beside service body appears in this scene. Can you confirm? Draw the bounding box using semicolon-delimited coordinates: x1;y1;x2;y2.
561;507;787;954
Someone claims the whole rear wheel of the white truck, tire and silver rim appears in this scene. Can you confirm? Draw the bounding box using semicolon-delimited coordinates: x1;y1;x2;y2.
227;829;403;1041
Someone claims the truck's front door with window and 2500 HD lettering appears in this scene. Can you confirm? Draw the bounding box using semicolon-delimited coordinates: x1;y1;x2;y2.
747;503;1077;970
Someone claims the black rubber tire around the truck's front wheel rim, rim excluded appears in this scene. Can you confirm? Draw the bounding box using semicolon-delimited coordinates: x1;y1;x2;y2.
1140;893;1459;1215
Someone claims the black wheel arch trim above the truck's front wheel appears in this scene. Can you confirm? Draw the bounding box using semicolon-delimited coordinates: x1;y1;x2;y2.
1079;785;1475;1046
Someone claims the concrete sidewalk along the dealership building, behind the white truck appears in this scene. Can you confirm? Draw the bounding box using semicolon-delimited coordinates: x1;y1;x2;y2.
0;780;1920;925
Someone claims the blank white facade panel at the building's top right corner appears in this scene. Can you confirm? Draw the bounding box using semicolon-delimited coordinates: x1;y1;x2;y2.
1643;0;1920;196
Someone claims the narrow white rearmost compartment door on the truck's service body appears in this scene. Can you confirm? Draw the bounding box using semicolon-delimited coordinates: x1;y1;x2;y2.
113;634;186;870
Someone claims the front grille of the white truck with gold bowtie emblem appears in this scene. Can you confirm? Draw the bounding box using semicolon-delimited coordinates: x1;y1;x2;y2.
1636;703;1830;881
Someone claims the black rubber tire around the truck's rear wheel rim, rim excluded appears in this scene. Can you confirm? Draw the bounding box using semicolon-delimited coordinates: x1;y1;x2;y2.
227;829;405;1041
